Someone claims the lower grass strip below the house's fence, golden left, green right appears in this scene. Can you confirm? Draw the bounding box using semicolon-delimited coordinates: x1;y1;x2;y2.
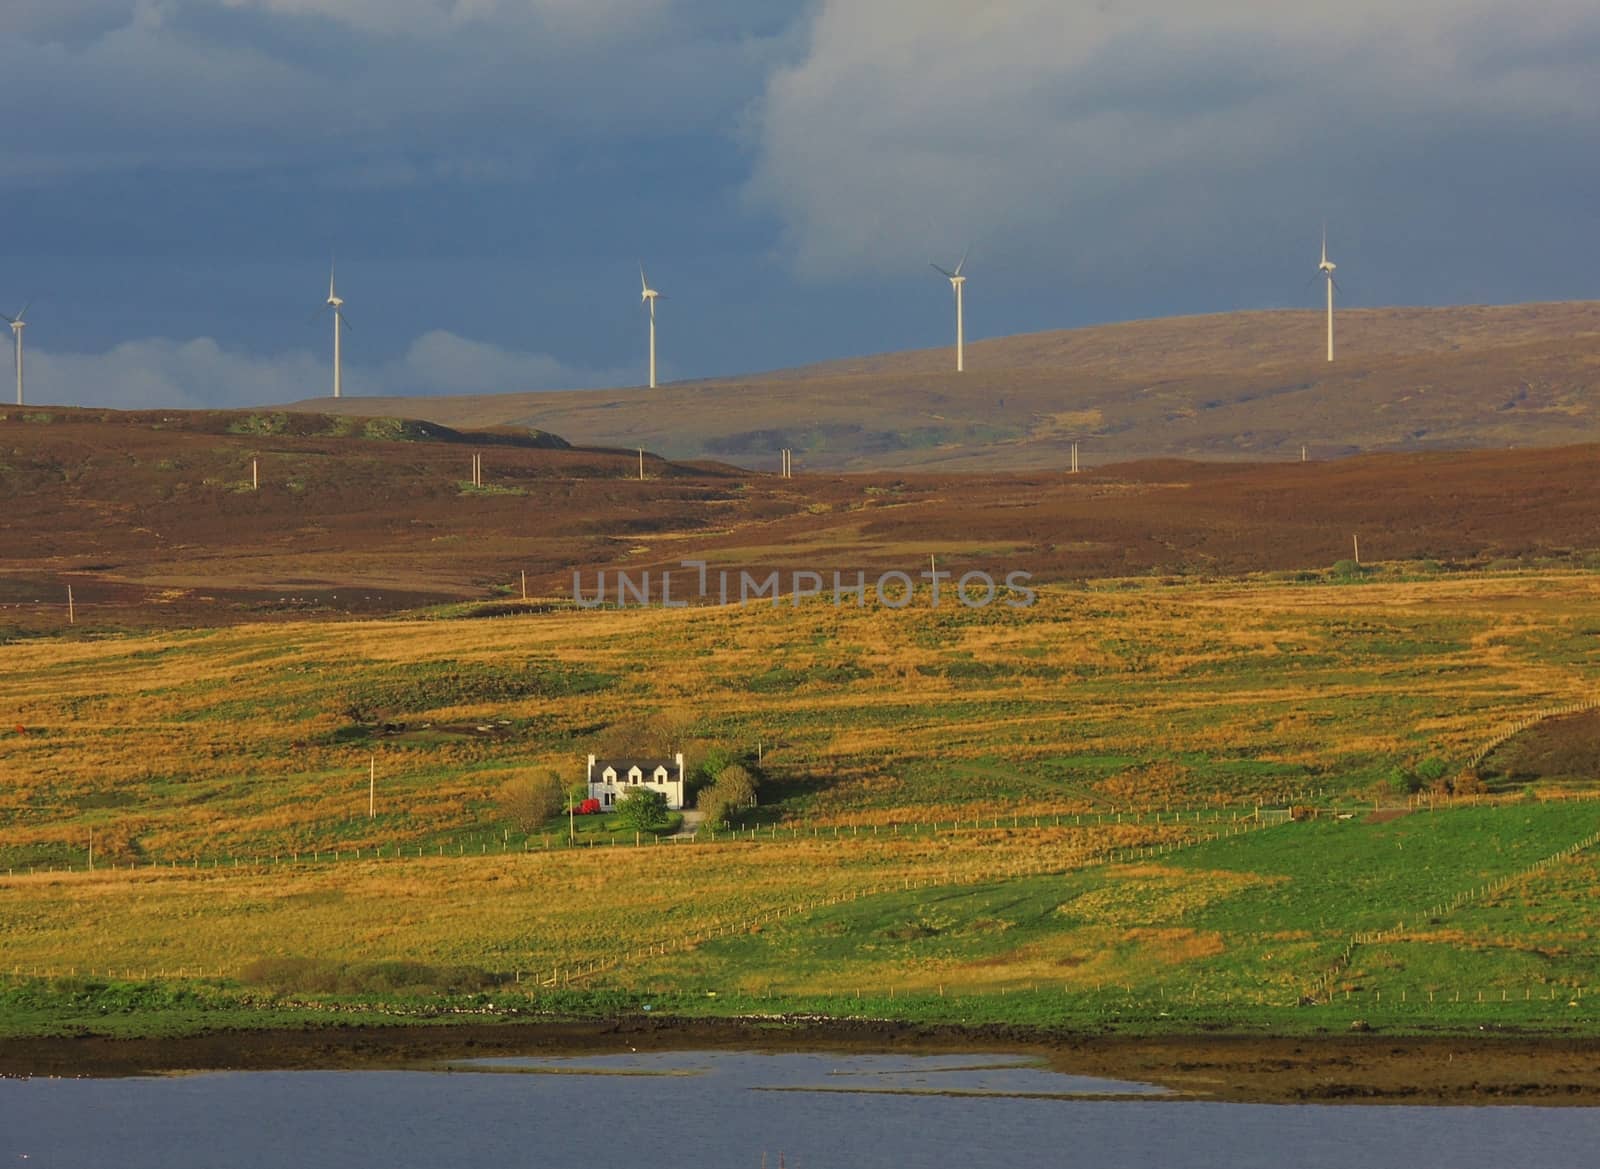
0;801;1600;1033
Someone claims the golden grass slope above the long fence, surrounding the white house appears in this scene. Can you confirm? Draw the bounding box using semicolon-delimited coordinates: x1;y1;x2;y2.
0;573;1600;860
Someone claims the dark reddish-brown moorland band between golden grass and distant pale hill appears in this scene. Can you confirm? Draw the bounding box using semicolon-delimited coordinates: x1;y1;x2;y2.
0;411;1600;633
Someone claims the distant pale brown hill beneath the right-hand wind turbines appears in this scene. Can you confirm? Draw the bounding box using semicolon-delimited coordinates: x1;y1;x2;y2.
281;302;1600;470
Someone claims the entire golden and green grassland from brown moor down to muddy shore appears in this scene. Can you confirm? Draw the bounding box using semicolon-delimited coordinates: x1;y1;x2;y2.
0;573;1600;1033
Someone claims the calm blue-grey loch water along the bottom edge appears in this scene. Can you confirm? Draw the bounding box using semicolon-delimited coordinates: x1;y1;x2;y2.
0;1051;1600;1169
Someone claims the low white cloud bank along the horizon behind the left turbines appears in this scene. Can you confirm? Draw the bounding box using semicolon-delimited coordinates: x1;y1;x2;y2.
26;329;626;409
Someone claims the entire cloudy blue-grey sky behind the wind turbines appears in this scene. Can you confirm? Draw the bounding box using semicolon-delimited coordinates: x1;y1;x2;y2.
0;0;1600;408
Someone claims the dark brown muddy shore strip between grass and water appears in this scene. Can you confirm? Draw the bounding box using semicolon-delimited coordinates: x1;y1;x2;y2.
0;1017;1600;1105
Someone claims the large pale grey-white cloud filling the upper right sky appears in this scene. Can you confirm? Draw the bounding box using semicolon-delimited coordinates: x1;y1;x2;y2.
746;0;1600;280
